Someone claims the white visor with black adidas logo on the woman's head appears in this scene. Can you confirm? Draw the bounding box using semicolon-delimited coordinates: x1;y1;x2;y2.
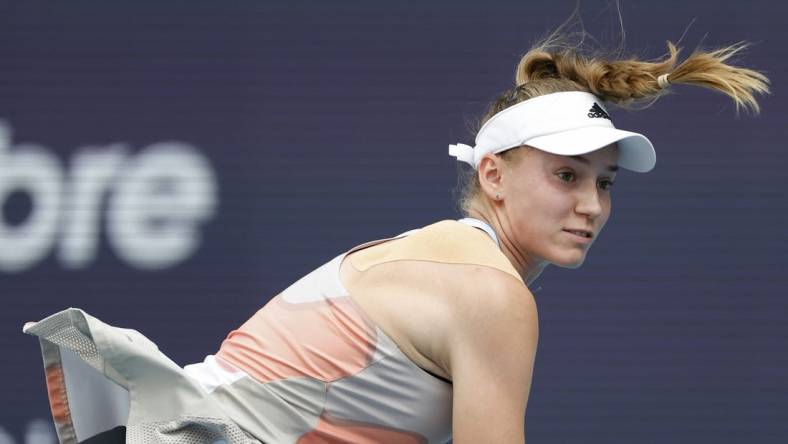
449;91;657;173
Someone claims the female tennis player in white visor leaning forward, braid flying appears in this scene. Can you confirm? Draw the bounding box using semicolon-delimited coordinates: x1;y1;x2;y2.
24;26;768;444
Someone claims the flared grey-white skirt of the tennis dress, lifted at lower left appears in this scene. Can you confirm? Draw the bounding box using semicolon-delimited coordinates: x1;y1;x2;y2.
23;308;262;444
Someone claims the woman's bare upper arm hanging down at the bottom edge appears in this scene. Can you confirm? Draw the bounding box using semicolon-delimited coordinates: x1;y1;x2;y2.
448;269;539;444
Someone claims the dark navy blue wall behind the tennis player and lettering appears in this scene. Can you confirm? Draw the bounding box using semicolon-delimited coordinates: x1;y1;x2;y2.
0;0;788;444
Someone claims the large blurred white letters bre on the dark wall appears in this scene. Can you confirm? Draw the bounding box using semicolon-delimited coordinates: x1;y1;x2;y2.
0;121;217;273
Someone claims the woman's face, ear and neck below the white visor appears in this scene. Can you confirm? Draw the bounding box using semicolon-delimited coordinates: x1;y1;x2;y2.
469;144;618;284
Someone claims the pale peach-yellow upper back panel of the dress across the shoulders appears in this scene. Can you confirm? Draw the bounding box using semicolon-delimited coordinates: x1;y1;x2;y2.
348;219;522;282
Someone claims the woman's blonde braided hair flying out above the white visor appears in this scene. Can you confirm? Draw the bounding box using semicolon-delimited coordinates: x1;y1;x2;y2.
458;25;769;215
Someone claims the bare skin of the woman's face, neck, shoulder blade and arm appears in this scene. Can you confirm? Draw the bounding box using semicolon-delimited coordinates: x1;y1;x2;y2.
340;145;618;444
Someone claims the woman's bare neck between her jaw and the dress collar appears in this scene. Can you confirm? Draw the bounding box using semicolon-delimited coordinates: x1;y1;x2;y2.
468;204;548;286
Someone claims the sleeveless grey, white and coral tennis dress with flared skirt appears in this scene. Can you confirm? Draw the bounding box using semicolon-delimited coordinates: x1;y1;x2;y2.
24;219;522;444
